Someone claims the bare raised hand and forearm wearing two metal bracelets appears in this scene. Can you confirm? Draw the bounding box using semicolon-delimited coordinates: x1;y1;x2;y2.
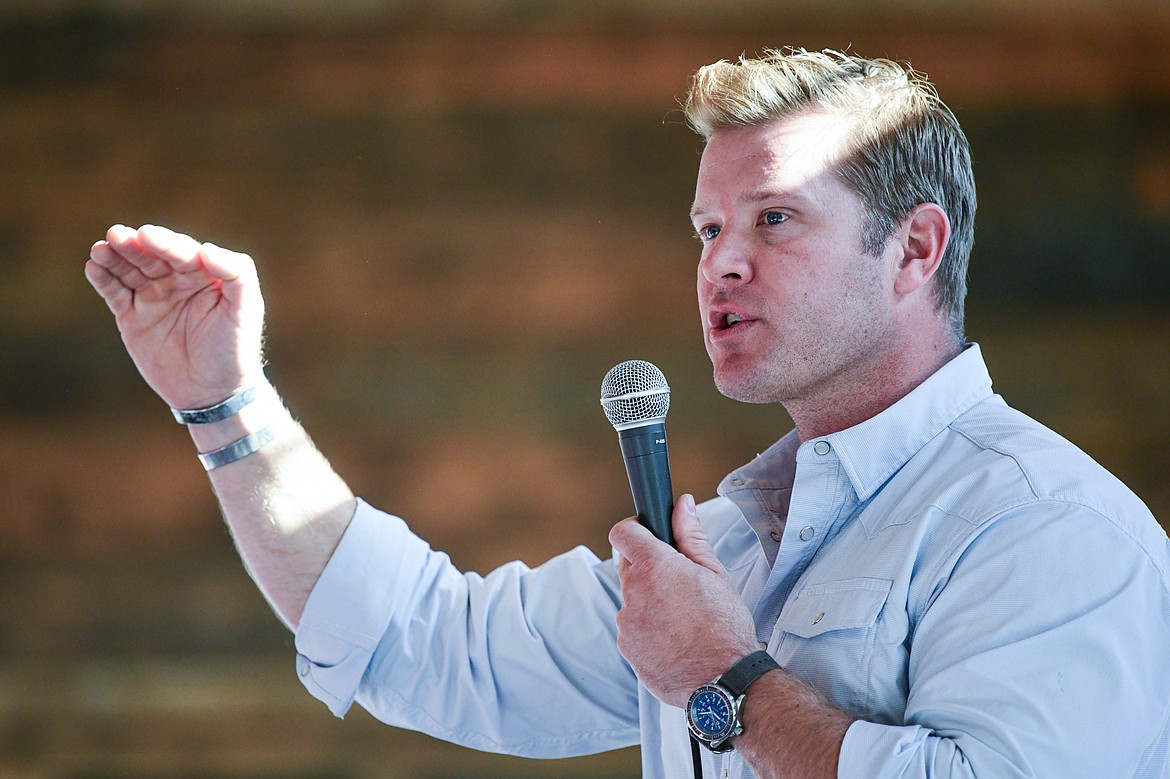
85;225;356;627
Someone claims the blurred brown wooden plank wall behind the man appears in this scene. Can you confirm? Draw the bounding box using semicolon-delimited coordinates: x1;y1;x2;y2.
0;0;1170;779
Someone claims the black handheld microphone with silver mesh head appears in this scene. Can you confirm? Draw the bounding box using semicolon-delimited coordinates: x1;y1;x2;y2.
601;360;674;546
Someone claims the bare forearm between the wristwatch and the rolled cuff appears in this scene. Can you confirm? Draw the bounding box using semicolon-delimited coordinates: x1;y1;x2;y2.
734;669;853;779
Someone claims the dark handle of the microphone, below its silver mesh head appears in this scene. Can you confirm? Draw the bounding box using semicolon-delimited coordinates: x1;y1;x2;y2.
618;422;674;546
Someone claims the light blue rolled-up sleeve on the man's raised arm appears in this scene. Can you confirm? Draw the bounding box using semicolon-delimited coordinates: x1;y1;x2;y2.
296;493;639;757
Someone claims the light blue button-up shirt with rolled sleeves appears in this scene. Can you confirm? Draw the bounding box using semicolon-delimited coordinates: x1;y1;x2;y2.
296;345;1170;779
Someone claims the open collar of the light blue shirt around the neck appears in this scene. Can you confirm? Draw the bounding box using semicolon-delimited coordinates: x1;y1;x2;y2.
718;343;991;501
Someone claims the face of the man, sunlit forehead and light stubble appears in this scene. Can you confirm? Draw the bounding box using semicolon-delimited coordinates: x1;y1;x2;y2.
691;113;896;411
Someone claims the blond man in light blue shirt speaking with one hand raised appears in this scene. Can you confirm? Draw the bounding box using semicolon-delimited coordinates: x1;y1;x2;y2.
87;50;1170;779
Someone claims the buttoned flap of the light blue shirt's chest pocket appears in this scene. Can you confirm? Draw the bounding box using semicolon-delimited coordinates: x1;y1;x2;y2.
777;578;894;639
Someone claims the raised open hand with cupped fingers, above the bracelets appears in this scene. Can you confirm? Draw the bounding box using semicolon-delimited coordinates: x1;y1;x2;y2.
85;225;264;408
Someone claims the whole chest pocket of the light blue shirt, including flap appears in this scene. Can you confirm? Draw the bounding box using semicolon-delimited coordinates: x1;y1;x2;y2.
770;578;893;715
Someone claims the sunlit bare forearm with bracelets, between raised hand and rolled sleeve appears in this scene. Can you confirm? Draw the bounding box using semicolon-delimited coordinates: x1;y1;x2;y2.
188;378;356;628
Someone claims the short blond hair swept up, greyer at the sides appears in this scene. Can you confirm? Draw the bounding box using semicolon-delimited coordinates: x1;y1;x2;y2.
682;49;976;339
